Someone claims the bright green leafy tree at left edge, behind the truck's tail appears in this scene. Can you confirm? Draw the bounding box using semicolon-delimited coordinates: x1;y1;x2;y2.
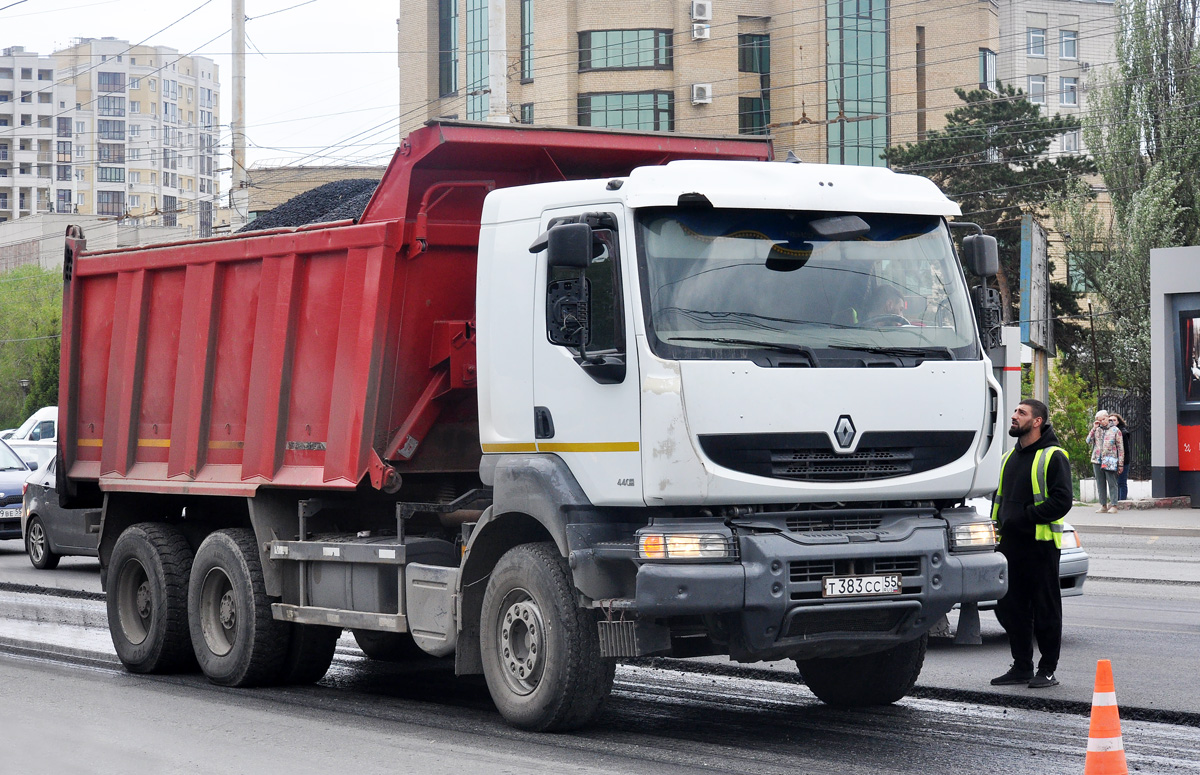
0;266;62;428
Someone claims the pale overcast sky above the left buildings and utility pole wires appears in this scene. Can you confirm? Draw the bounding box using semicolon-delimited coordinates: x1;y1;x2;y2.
0;0;400;170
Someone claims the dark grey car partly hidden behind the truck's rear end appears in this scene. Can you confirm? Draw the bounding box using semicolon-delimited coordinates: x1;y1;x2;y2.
22;458;100;570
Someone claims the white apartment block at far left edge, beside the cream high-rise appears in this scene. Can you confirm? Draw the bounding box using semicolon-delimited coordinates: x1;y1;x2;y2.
0;46;76;222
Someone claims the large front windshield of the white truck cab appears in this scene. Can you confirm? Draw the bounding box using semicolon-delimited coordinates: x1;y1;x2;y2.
637;208;979;365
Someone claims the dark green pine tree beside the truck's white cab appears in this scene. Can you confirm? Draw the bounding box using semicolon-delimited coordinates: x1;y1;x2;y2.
884;85;1096;349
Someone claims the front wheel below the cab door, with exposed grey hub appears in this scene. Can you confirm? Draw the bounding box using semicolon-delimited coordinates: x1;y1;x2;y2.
480;543;616;732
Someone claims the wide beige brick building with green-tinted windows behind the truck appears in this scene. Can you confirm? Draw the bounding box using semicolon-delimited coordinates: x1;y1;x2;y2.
398;0;1000;164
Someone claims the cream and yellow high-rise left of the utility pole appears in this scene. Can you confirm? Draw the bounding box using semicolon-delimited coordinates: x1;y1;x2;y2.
54;37;220;236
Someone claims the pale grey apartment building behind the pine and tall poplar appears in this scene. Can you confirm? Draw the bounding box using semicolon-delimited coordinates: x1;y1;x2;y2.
998;0;1117;154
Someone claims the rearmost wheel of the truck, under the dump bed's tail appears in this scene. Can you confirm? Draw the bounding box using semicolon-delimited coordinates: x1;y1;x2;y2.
106;522;196;673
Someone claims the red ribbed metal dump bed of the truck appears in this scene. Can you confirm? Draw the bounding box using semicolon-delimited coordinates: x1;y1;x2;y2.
59;124;770;495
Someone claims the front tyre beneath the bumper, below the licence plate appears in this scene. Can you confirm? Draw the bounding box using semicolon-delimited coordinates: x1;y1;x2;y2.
796;633;929;708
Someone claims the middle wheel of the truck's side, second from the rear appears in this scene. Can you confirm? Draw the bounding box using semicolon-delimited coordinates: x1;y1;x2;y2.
187;528;289;686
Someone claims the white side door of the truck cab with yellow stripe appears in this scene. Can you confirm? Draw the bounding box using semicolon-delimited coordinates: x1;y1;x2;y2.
533;205;643;505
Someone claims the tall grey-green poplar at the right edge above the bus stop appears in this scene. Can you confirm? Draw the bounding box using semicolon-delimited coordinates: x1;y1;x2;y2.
1063;0;1200;392
